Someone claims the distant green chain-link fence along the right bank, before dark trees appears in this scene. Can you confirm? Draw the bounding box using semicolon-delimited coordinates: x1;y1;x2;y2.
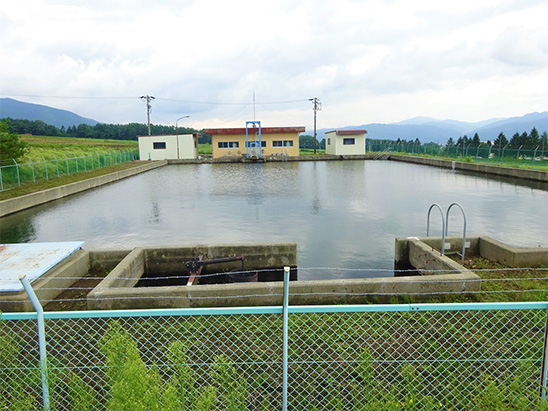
366;140;548;165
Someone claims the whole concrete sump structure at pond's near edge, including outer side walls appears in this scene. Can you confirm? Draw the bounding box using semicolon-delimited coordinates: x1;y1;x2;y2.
0;236;548;312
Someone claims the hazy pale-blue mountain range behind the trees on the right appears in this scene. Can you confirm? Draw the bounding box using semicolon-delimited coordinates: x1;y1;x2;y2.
317;111;548;144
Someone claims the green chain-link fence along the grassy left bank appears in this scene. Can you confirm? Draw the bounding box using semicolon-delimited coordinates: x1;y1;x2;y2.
0;150;139;191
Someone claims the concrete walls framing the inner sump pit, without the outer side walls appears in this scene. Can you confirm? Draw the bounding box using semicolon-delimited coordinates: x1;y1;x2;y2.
88;239;480;310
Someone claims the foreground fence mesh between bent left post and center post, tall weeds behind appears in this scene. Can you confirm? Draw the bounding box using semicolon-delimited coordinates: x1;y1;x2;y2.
43;314;282;409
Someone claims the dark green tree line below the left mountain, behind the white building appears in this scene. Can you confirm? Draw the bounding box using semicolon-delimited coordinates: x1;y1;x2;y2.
0;118;201;140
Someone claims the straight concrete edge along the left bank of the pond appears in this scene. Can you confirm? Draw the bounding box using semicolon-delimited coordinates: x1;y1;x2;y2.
0;160;167;217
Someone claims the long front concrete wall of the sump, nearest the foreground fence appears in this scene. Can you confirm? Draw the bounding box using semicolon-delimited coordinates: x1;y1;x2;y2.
84;272;480;310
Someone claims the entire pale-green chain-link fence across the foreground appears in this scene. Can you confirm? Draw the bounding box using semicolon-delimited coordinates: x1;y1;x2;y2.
0;303;548;410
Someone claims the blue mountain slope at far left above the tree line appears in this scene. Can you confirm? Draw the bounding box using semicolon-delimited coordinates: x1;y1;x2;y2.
0;98;98;128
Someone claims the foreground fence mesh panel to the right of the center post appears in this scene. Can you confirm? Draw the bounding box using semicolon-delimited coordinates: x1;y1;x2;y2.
288;310;545;409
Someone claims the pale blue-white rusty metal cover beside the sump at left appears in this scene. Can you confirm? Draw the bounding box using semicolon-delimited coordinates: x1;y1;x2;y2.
0;241;84;292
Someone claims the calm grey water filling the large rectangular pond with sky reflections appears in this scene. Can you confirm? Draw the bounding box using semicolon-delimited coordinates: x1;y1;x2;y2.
0;161;548;279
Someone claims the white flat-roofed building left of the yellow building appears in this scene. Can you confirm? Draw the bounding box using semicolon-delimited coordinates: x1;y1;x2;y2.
137;134;200;160
